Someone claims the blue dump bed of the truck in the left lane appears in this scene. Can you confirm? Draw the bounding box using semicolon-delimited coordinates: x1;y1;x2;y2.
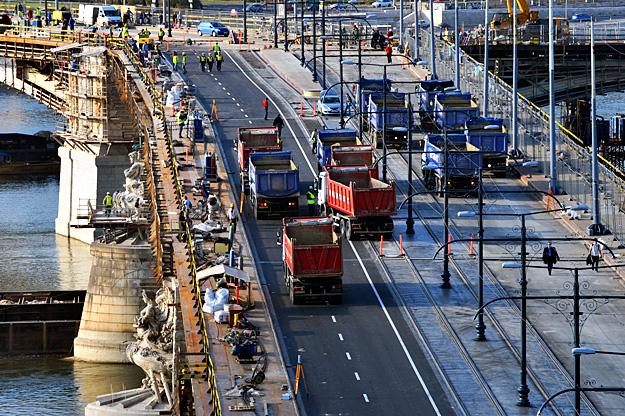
249;152;299;197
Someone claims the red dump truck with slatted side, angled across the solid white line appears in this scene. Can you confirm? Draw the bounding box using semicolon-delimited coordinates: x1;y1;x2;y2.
318;166;397;240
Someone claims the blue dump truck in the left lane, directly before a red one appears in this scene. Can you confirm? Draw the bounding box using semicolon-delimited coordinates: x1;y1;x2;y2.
249;152;299;219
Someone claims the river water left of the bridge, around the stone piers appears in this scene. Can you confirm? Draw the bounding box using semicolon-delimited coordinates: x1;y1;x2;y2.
0;87;143;416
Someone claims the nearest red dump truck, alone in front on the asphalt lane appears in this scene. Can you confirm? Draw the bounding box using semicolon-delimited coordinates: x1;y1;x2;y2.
282;217;343;305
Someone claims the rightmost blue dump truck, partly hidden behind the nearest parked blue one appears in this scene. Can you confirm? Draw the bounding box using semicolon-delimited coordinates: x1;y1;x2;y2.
464;117;508;178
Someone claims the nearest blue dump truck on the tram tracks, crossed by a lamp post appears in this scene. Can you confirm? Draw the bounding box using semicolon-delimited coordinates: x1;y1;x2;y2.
421;134;482;196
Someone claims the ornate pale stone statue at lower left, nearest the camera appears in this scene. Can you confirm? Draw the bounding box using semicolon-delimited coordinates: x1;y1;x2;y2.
126;288;175;405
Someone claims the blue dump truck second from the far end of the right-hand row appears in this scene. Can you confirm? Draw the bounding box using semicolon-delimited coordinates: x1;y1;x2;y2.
434;91;479;131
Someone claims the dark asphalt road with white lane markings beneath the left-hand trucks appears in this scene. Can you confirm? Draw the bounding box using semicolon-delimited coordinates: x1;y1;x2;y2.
168;46;456;416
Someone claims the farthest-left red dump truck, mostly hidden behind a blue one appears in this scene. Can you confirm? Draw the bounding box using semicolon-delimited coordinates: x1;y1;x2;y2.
237;127;282;190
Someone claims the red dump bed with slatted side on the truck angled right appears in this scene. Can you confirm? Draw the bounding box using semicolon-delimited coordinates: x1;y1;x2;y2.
325;166;397;217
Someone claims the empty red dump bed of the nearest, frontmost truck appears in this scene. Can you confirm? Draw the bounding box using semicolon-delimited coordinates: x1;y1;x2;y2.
283;218;343;279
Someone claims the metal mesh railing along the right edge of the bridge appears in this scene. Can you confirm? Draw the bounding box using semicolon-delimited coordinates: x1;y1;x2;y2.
412;36;625;241
